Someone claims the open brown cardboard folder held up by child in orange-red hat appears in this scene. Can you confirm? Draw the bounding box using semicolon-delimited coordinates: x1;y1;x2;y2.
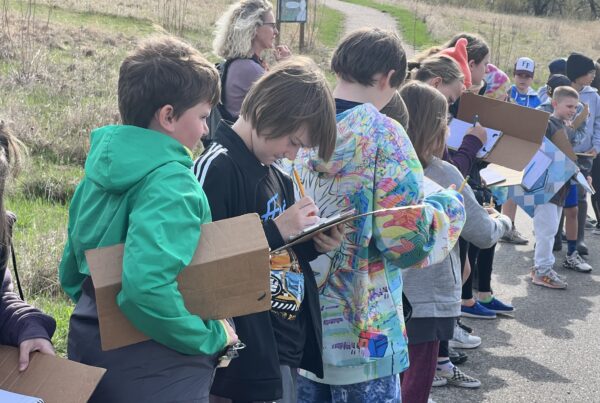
457;93;550;171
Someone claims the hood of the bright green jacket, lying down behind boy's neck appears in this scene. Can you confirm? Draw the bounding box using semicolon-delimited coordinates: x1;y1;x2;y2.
85;125;192;194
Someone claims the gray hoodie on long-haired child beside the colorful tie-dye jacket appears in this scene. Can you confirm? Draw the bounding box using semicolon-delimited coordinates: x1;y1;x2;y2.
402;158;512;318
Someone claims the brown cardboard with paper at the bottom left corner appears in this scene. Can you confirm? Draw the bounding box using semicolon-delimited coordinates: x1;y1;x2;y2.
0;346;106;403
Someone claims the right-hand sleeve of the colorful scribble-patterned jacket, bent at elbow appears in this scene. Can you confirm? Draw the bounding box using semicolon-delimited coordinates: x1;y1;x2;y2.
373;121;465;268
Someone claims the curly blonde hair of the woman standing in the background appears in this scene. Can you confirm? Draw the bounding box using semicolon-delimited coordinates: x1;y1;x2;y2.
213;0;273;59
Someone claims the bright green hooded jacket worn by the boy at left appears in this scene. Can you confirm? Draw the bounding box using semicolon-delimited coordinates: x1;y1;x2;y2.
59;126;226;354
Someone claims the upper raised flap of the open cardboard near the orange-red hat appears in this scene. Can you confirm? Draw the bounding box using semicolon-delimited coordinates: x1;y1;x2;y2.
457;93;550;148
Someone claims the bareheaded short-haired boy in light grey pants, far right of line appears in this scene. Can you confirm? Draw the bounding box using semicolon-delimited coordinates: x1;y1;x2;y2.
532;87;592;289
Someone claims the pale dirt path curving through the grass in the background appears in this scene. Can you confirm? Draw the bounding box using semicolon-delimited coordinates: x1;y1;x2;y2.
325;0;414;57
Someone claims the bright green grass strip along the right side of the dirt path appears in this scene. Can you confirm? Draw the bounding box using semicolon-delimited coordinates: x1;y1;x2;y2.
343;0;435;49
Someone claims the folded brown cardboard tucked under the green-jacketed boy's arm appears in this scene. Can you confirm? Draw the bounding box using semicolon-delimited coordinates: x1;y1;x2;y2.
85;214;271;350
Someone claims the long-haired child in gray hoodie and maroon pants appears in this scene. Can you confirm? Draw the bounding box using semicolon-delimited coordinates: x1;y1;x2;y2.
400;82;511;403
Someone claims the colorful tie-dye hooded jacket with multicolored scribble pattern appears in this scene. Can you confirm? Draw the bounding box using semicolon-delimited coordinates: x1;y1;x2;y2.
294;104;465;385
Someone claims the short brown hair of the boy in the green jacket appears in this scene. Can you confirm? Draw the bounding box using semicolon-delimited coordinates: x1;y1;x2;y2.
119;36;221;128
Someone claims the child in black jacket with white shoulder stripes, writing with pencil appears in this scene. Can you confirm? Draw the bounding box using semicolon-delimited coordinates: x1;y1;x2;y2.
194;58;341;403
